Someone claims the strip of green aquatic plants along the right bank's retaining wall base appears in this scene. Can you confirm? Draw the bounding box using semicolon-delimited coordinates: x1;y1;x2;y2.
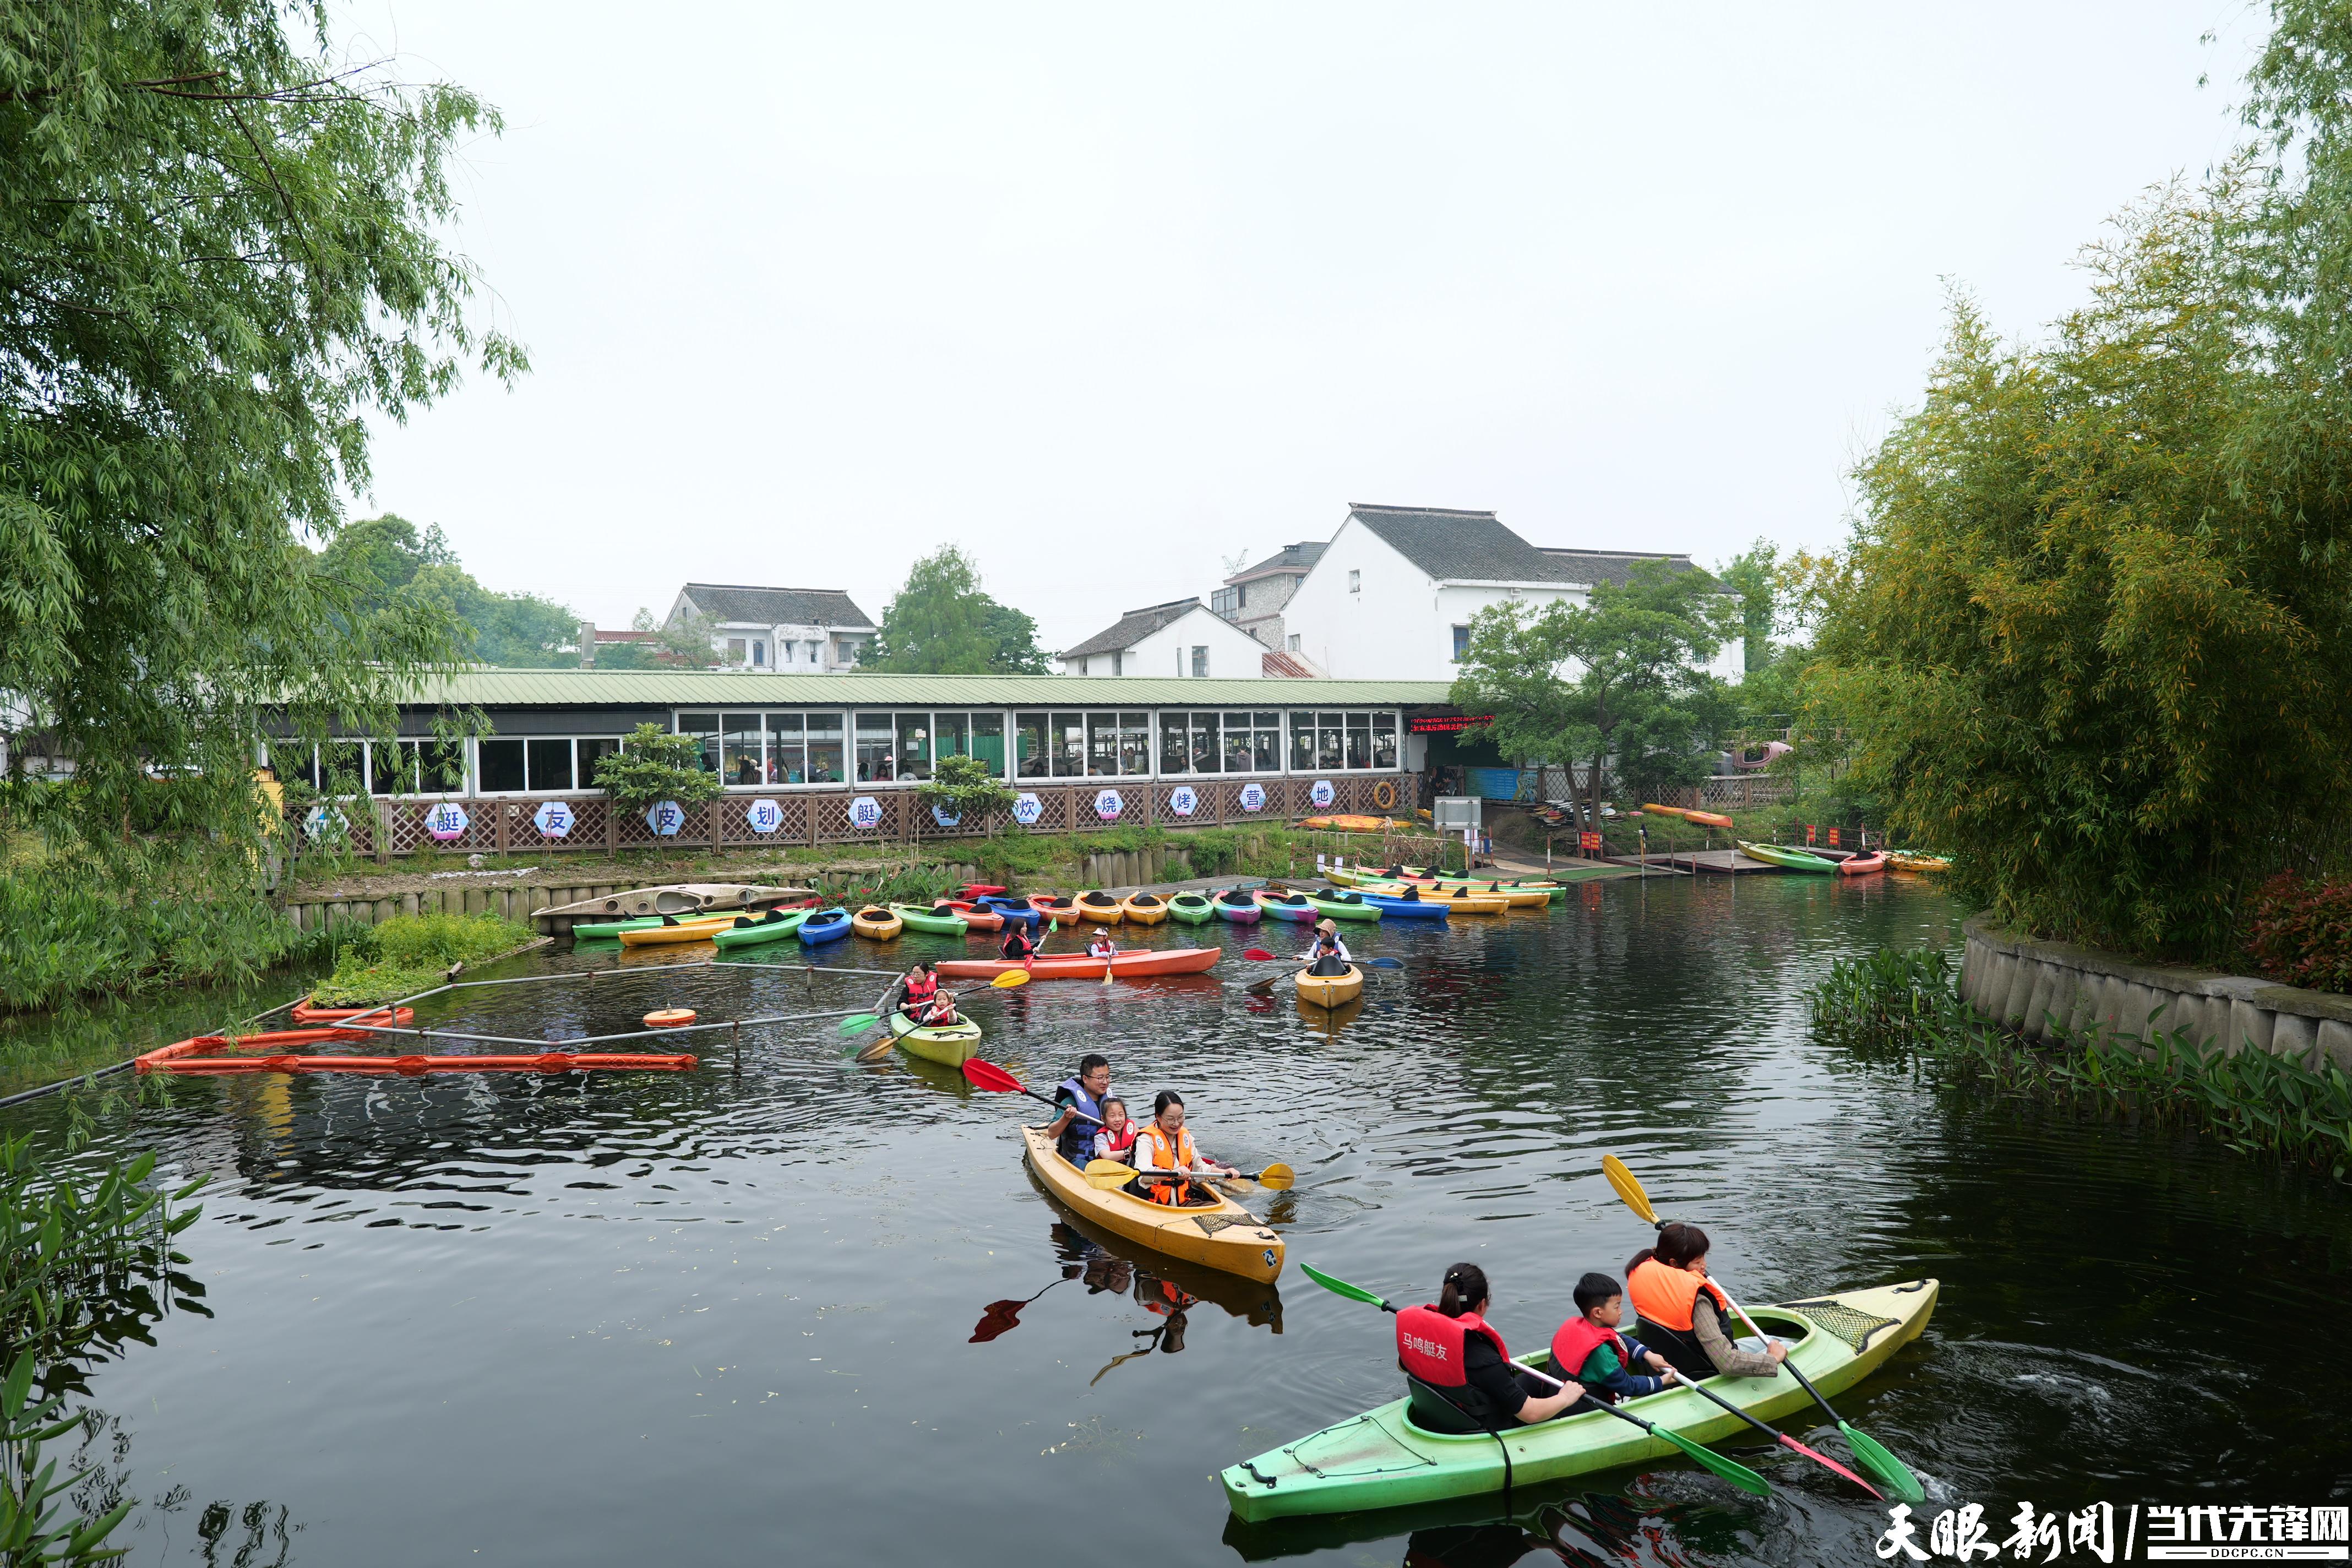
1806;950;2352;1180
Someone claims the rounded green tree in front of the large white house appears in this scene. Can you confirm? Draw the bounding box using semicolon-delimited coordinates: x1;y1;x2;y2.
1451;562;1740;820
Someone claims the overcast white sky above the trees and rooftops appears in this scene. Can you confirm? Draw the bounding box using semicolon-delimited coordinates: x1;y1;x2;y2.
344;0;2263;646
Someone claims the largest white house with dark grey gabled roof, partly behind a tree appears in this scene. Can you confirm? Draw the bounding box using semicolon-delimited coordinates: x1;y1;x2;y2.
1282;503;1745;682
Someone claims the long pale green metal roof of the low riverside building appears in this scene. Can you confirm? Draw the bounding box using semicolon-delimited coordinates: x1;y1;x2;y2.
416;670;1449;707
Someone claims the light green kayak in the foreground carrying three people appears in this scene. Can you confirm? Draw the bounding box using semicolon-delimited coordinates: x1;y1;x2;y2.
1218;1279;1938;1518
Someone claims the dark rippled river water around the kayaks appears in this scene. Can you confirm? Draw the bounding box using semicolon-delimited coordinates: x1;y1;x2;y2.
9;877;2352;1568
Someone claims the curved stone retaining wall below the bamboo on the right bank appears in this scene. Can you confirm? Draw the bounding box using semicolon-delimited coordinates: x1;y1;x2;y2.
1959;914;2352;1072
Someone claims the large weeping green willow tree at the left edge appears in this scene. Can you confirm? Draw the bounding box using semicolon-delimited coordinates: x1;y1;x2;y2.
0;0;522;837
